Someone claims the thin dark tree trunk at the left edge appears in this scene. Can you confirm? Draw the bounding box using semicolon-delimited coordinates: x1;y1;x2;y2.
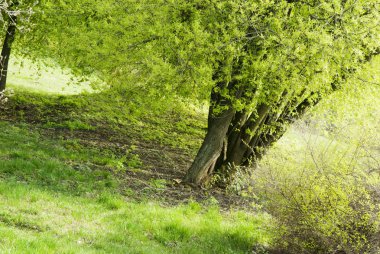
0;15;17;91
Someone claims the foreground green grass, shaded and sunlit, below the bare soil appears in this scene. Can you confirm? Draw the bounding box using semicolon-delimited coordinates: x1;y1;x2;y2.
0;122;270;253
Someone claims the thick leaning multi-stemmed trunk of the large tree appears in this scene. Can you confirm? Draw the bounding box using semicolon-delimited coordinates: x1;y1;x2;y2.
184;89;311;187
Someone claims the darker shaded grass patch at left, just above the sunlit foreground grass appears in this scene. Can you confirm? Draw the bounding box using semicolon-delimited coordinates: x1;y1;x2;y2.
0;122;117;195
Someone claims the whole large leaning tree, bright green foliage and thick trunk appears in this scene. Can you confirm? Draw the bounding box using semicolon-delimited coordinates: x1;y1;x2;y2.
8;0;380;183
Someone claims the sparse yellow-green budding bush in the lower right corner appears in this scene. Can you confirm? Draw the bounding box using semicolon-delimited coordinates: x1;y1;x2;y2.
254;120;380;253
